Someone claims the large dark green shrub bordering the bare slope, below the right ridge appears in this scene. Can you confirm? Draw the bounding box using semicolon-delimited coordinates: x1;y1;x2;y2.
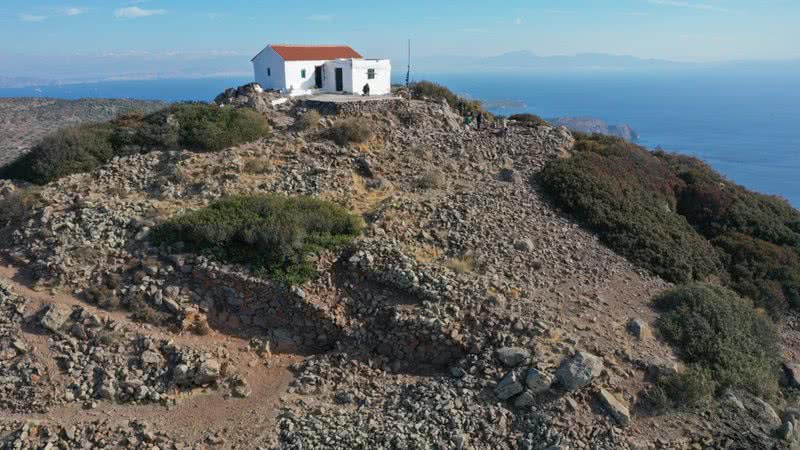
541;137;720;282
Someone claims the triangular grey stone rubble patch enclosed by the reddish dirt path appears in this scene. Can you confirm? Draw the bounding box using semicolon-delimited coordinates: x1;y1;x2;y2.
40;305;223;405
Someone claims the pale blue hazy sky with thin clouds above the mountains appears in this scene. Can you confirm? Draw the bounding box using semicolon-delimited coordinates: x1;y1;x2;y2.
0;0;800;76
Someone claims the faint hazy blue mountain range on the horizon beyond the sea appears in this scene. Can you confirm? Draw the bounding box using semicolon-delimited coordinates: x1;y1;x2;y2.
0;50;800;88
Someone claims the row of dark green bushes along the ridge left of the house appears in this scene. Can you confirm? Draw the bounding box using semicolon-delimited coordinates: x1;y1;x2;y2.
0;103;270;184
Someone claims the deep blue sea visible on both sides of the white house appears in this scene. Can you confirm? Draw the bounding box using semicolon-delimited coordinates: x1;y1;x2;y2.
0;69;800;207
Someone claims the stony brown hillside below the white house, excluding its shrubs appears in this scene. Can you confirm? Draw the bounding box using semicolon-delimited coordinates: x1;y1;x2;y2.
0;87;795;450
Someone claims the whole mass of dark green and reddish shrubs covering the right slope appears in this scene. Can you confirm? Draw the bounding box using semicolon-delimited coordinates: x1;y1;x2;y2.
540;134;800;317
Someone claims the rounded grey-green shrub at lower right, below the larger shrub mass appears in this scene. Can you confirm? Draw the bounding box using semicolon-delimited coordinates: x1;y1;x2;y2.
655;284;781;397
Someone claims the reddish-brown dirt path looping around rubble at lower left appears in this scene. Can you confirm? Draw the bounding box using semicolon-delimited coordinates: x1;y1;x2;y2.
0;266;302;448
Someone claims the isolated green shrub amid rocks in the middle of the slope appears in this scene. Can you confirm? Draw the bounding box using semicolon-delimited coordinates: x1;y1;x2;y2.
153;195;361;283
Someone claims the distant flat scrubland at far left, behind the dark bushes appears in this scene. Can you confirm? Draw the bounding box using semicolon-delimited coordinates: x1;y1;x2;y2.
0;98;165;165
